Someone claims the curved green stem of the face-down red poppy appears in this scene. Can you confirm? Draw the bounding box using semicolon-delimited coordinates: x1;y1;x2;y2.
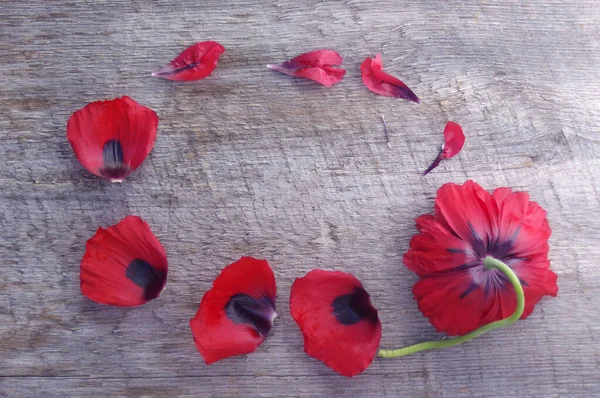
377;257;525;358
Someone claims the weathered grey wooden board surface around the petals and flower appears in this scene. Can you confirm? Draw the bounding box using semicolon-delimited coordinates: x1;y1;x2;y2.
0;0;600;397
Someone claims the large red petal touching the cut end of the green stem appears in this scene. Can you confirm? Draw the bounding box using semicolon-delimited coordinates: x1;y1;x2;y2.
290;269;381;377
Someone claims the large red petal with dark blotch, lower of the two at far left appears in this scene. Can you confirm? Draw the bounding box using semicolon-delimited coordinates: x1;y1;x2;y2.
80;216;168;307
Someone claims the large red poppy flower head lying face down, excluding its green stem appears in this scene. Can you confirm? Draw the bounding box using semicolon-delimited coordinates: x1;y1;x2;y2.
404;181;558;335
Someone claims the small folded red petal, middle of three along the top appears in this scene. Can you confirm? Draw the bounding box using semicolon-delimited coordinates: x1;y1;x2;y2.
267;50;346;87
